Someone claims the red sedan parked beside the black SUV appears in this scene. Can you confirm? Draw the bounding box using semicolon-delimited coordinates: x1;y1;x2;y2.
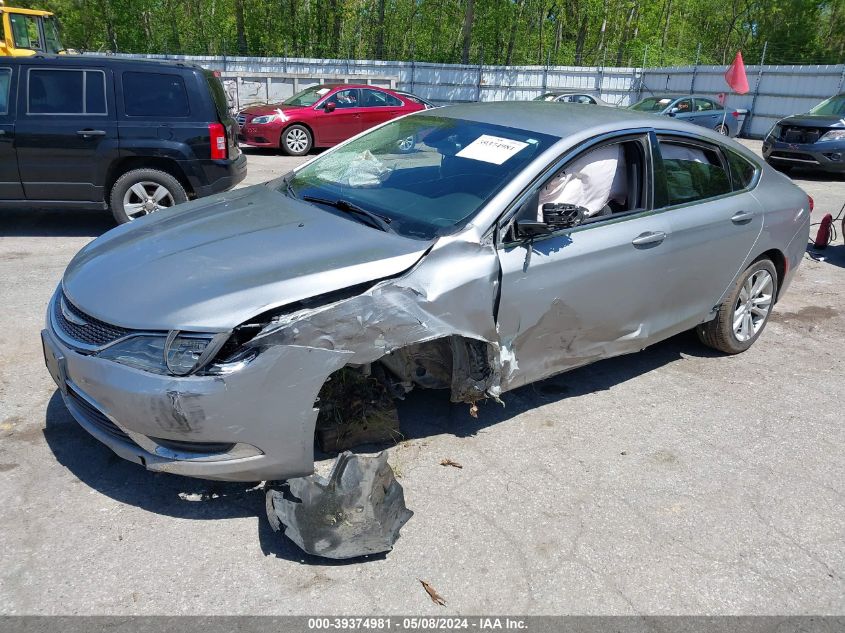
237;84;426;156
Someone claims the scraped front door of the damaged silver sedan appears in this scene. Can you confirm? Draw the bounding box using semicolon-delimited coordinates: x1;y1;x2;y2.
498;135;670;389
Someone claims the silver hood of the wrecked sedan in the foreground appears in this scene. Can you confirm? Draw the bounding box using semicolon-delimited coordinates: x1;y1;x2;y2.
62;185;431;332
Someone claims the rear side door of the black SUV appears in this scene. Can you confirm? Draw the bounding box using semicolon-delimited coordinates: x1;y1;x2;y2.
15;64;118;202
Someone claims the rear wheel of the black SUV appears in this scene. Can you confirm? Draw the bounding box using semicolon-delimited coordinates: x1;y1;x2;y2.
109;169;188;224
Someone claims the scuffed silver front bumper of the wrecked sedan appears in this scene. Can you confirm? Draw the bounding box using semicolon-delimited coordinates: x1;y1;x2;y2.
41;310;346;481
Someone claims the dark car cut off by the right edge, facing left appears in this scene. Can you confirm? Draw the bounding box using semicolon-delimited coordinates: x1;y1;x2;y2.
763;94;845;172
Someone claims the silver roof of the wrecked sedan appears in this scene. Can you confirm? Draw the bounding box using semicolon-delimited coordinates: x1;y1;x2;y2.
422;101;732;139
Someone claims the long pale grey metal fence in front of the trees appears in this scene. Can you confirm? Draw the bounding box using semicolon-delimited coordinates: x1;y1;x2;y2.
100;55;845;138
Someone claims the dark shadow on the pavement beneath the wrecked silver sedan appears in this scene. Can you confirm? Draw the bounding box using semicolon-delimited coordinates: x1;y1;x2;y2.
44;333;719;566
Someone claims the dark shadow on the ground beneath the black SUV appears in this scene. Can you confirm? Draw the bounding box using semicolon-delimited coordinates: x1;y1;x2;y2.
0;209;116;237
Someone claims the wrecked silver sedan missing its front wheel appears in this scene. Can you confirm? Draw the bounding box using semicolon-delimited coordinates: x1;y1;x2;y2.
42;102;810;480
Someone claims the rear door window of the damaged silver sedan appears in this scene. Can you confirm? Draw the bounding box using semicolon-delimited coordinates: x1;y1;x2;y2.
660;140;731;205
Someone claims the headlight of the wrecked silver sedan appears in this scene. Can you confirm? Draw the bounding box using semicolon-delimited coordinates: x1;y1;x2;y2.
98;331;223;376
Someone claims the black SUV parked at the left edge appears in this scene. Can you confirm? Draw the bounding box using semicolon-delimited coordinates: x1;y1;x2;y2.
0;55;246;222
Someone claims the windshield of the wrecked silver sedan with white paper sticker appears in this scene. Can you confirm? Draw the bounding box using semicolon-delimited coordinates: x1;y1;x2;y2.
280;115;559;240
